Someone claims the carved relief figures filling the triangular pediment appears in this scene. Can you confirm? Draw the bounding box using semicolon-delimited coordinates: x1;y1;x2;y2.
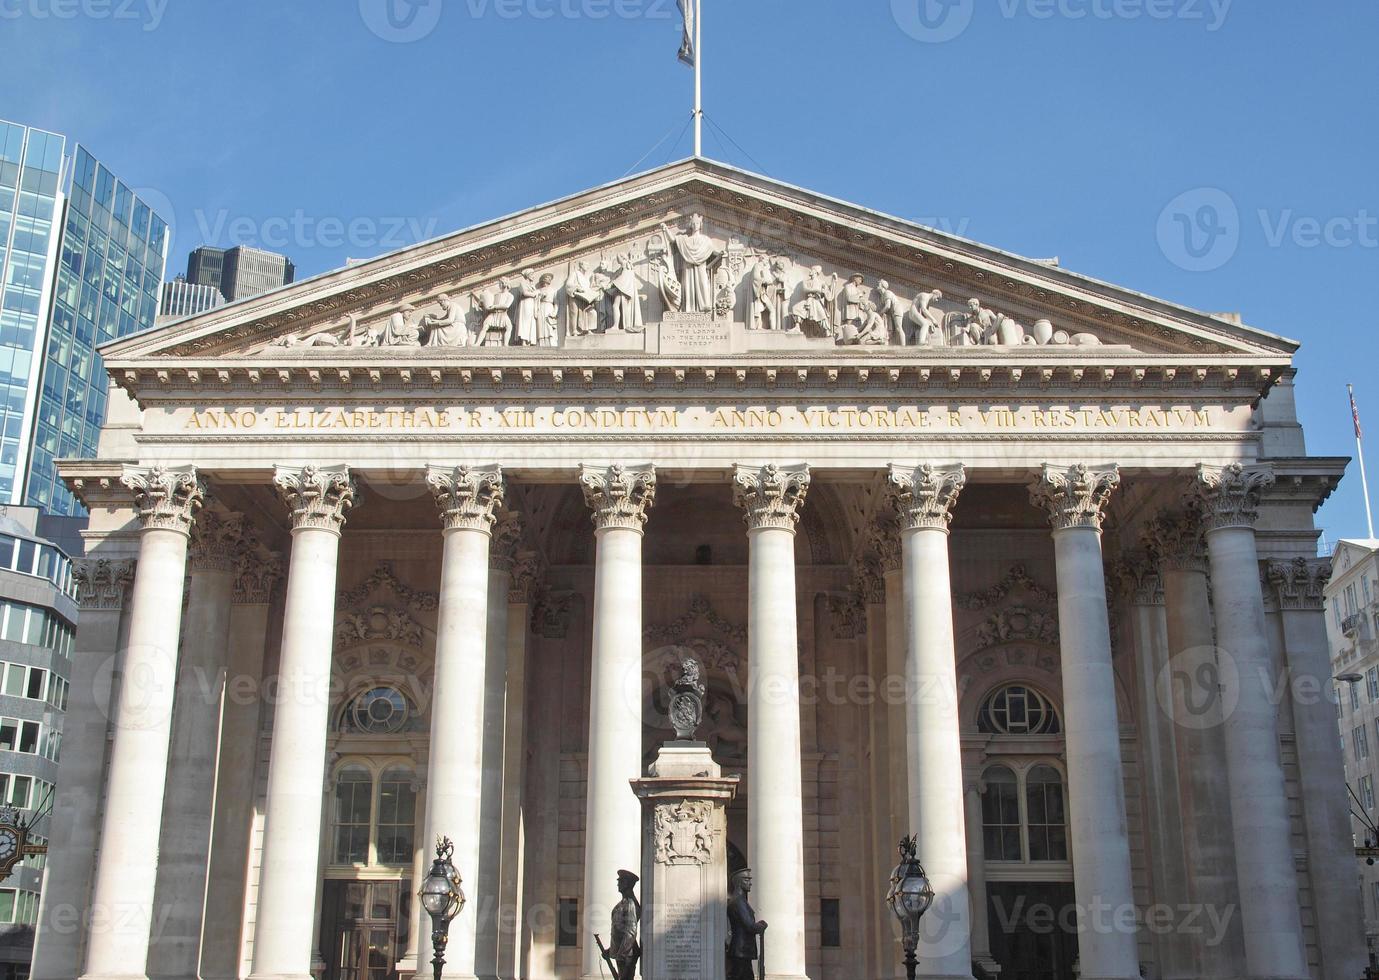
248;214;1102;353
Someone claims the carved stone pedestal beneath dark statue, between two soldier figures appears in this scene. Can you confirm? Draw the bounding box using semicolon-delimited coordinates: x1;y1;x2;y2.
632;742;738;980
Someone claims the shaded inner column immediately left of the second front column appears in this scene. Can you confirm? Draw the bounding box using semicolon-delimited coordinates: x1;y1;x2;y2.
200;551;283;980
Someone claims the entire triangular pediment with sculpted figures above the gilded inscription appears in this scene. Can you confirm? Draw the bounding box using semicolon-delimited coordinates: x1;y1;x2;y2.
102;160;1298;367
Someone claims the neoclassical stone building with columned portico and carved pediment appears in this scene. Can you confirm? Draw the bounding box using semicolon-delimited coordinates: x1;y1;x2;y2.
34;160;1364;980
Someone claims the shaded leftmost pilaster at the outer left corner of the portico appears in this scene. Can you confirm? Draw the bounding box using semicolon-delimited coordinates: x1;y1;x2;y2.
32;558;134;980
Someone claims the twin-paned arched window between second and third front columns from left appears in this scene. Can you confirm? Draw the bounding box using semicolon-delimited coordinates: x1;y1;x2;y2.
332;764;416;867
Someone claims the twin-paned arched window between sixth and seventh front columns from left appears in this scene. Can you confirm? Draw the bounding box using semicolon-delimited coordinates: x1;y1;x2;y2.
982;764;1067;863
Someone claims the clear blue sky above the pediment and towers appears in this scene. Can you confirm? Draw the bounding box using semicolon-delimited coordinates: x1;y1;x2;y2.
0;0;1379;539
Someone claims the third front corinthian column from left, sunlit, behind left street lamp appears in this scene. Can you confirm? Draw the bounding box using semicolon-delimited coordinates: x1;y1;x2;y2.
426;466;503;977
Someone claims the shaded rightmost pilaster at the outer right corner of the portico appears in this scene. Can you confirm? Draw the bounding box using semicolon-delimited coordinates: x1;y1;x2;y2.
1267;558;1368;977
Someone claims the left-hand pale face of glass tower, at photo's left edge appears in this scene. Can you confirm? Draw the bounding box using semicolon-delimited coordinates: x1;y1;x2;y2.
0;121;66;512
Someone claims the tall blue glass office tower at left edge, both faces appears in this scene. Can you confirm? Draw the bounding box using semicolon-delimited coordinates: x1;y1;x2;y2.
0;121;168;514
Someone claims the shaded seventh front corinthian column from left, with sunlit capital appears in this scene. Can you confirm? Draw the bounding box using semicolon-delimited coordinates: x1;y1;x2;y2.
1030;465;1139;980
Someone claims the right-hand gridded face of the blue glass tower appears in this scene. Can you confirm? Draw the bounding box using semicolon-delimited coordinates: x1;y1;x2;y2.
23;146;168;514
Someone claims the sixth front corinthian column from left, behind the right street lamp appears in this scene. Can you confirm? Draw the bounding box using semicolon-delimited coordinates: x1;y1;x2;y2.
891;465;972;980
